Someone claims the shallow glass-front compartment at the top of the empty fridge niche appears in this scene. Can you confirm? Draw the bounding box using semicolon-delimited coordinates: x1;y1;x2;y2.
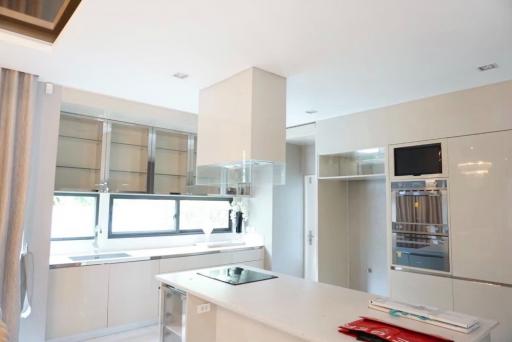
318;148;385;180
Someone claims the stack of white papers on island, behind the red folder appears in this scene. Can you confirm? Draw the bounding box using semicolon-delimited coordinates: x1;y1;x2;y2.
369;298;479;333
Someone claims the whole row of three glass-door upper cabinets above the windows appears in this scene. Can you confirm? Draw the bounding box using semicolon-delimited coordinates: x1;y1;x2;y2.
55;113;196;194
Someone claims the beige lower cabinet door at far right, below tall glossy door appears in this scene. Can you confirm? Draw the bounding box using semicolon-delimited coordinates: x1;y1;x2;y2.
453;279;512;342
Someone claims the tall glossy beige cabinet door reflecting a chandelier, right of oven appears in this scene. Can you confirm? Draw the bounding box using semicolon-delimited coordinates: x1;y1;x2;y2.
448;131;512;284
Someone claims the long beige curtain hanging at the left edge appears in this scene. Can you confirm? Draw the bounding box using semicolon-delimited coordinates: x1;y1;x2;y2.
0;69;37;342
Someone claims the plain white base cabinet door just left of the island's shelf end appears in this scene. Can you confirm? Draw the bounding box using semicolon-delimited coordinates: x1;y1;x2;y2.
108;260;159;327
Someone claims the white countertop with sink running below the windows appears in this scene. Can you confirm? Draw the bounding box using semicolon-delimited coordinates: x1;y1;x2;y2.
50;242;262;268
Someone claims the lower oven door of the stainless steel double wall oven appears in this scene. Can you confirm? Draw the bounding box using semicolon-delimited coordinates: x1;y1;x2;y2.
393;227;450;272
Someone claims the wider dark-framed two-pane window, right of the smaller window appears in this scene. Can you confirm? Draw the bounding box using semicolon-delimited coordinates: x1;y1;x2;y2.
109;195;231;238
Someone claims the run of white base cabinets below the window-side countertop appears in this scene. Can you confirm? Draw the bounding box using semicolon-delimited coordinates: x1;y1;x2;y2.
46;248;264;341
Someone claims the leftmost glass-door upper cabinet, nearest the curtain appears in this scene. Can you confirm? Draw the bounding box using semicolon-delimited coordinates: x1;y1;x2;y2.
55;115;103;191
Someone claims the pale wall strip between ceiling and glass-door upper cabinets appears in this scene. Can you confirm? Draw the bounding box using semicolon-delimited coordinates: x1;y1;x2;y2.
62;87;197;132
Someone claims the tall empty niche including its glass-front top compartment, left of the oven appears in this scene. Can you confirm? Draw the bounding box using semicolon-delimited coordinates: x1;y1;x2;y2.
317;147;389;296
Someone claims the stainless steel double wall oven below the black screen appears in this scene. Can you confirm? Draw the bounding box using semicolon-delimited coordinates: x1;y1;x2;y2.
391;179;450;272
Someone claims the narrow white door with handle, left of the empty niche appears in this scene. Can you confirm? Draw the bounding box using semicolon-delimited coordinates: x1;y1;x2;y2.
304;176;318;281
